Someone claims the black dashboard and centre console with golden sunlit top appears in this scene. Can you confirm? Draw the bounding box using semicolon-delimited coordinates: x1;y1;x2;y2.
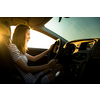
61;39;100;83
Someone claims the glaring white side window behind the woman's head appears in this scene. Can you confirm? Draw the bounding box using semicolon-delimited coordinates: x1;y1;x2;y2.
11;26;55;49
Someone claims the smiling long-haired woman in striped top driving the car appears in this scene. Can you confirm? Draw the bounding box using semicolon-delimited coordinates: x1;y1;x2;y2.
8;25;63;84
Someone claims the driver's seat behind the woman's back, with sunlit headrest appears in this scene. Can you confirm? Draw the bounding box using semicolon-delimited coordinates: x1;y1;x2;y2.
0;21;25;84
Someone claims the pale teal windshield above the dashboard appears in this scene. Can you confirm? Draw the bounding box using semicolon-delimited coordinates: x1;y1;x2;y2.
45;17;100;41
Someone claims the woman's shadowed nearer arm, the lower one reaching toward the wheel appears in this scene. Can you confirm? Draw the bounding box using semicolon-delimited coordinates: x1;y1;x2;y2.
15;58;58;73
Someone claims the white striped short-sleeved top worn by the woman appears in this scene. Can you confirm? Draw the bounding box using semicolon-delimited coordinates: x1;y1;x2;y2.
8;43;43;84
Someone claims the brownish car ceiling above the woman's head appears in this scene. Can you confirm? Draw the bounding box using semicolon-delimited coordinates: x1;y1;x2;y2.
0;17;52;29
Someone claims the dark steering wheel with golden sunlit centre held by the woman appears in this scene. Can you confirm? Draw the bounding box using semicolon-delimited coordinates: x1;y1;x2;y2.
49;39;63;61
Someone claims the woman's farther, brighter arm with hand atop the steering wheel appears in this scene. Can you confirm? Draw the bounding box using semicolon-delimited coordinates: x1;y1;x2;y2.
27;44;53;62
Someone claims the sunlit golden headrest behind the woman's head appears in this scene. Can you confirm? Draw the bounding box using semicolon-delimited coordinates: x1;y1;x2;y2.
0;21;11;36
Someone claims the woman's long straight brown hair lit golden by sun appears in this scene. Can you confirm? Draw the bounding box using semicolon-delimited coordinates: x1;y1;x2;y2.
12;25;30;54
